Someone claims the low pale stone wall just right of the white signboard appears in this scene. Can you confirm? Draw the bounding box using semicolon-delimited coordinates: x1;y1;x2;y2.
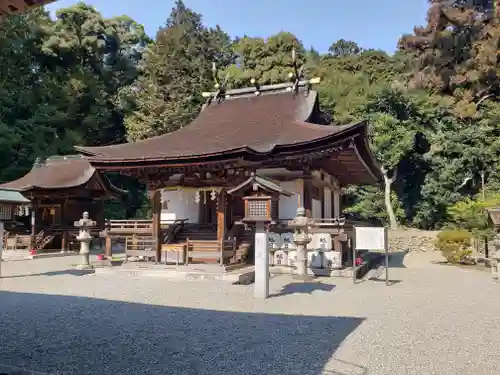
388;229;439;251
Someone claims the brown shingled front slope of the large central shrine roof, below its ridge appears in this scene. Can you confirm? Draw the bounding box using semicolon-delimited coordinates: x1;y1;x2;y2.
77;91;356;161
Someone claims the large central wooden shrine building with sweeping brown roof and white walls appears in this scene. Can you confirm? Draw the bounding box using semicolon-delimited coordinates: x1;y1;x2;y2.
76;69;382;263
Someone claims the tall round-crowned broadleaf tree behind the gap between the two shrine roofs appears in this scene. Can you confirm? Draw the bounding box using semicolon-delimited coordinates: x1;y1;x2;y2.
43;3;147;145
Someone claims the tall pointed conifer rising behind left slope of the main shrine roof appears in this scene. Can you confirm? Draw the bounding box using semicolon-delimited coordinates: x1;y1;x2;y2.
121;0;232;140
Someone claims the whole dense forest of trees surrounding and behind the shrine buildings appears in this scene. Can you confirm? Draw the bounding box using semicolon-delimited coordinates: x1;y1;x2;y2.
0;0;500;228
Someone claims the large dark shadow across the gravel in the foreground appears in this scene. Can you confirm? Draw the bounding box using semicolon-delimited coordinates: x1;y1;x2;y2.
0;291;366;375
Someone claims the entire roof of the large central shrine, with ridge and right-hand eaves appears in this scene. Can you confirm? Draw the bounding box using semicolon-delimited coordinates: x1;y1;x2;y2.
76;84;381;183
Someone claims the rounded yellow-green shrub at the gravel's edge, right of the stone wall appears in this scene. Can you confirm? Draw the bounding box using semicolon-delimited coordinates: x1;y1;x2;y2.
436;230;472;263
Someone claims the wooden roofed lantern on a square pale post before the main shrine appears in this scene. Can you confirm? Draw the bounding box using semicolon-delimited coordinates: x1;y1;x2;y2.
227;173;292;298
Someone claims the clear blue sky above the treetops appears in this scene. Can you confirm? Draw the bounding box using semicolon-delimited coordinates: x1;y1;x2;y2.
48;0;428;52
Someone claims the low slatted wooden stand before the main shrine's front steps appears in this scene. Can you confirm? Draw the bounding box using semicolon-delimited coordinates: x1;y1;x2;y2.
186;238;236;265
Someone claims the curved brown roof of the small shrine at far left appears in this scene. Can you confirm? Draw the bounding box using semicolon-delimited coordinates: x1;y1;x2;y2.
0;155;124;194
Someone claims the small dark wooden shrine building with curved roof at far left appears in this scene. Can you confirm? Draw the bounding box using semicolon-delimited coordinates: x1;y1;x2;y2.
0;155;125;250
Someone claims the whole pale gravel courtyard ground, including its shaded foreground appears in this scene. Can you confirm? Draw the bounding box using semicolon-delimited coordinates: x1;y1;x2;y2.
0;254;500;375
